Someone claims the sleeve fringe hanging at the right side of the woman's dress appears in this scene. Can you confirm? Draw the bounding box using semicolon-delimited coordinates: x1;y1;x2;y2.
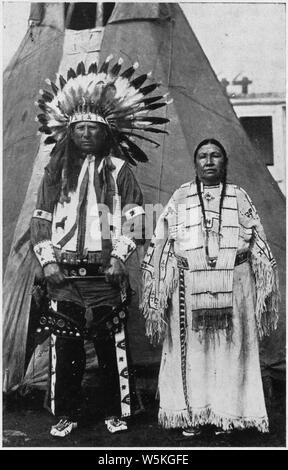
251;252;280;339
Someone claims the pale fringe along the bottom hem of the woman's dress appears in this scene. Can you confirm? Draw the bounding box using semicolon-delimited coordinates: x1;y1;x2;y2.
158;407;269;433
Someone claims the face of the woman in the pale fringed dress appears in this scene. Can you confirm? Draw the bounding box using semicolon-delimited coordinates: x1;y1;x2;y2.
195;144;225;186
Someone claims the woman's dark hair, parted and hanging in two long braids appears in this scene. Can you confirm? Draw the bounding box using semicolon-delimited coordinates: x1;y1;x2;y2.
194;138;228;235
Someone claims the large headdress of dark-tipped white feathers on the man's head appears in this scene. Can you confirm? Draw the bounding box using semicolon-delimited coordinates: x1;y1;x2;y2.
35;56;172;164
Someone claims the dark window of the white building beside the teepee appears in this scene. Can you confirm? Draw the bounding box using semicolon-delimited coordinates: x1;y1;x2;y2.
240;116;274;165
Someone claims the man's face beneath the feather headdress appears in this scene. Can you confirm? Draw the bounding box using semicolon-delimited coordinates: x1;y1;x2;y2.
72;122;107;153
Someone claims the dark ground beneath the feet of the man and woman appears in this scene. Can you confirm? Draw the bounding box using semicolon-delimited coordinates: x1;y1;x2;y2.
3;382;286;448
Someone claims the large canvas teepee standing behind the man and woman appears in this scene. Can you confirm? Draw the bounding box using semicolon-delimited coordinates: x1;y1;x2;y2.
3;2;285;391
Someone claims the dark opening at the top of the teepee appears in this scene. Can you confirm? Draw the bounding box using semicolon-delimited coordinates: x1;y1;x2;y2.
65;2;115;31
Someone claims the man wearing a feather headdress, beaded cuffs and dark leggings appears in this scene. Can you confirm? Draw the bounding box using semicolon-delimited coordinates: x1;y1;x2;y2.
31;57;168;437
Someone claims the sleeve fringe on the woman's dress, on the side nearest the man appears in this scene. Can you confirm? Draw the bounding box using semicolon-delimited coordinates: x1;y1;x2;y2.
141;258;179;344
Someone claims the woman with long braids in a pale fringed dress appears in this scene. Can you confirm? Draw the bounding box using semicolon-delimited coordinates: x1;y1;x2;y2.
143;139;279;436
